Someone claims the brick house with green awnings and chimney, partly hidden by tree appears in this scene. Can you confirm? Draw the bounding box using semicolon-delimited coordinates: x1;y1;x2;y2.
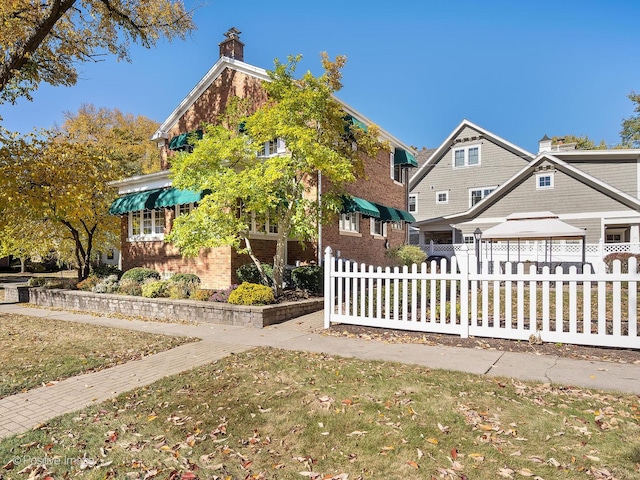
110;28;417;288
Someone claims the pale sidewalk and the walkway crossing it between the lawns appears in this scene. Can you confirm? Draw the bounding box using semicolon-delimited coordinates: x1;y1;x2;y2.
0;303;640;438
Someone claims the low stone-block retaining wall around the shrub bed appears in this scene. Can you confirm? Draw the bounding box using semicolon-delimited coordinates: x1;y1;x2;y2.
5;285;324;328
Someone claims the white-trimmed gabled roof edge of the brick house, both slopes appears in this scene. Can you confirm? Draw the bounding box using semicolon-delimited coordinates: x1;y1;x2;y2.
151;56;417;156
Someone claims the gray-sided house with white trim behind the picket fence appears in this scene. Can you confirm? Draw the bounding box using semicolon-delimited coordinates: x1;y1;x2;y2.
409;120;640;260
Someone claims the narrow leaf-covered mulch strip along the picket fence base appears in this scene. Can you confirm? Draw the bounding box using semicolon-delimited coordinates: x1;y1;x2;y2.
323;325;640;365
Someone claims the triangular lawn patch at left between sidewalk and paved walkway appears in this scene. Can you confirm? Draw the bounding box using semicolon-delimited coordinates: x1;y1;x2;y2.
0;314;193;398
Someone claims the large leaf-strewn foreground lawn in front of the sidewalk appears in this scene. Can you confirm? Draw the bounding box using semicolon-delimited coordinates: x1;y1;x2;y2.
0;349;640;480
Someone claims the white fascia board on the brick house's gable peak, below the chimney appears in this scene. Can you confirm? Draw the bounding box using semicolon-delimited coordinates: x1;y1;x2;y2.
151;57;269;141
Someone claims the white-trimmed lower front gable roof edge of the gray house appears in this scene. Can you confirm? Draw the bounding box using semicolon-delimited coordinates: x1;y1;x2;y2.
414;152;640;225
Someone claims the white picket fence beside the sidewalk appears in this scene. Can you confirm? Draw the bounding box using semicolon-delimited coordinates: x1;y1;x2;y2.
324;248;640;349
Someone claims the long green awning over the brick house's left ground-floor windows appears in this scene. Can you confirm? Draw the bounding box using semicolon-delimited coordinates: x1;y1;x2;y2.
109;188;206;215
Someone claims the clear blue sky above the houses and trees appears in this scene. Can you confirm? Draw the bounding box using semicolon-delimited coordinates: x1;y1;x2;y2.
0;0;640;152
